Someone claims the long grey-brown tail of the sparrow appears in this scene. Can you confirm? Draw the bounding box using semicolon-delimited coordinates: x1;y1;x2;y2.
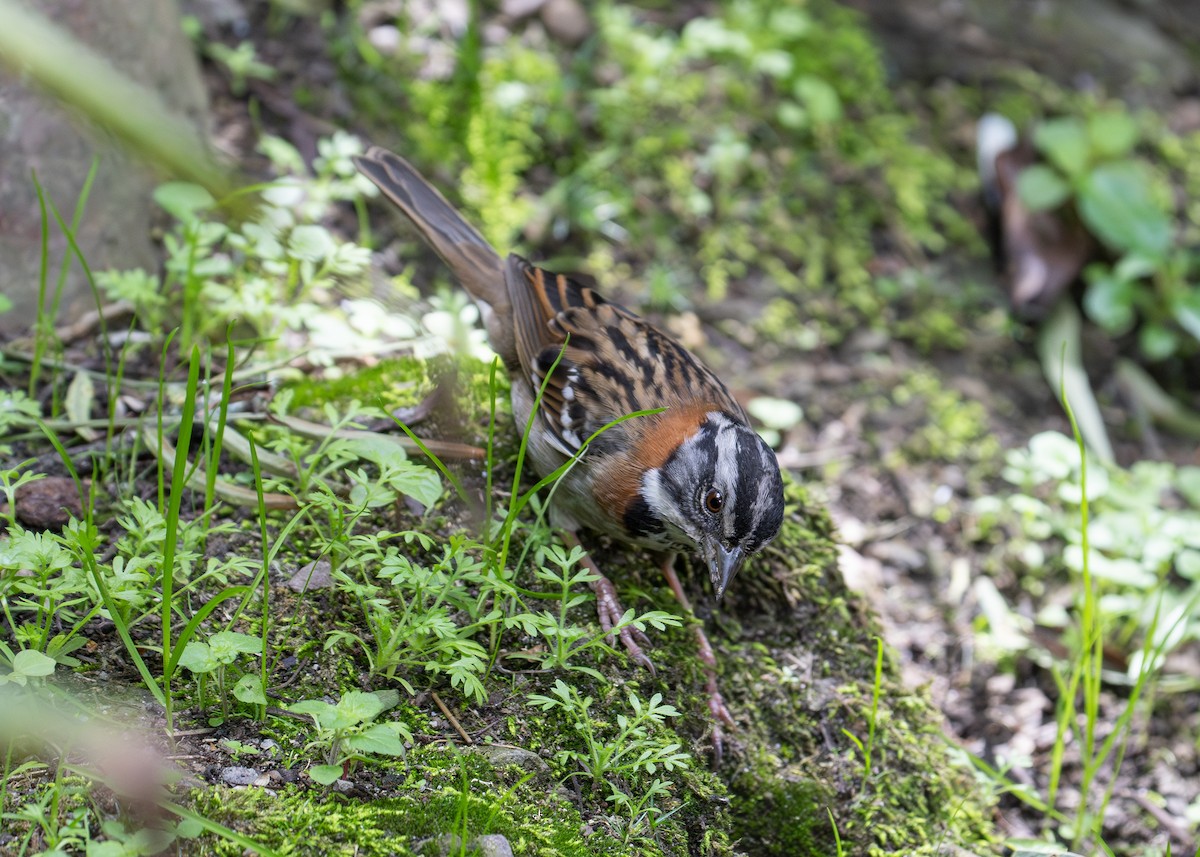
354;146;510;318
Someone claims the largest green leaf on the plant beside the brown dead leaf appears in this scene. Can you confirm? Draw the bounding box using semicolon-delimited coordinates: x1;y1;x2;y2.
1079;161;1171;258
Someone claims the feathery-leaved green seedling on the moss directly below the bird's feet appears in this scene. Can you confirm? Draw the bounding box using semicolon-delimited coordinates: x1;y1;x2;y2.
529;678;690;843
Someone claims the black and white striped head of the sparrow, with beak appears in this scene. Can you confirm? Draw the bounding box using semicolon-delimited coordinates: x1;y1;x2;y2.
641;412;784;598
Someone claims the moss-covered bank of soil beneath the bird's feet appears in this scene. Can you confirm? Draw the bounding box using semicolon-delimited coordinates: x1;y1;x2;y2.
177;360;994;857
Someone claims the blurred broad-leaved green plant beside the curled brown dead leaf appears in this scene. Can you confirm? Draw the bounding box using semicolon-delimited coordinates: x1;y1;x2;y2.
1016;109;1200;360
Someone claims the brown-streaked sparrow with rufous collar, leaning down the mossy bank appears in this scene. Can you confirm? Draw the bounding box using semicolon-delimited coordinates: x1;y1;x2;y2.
355;146;784;754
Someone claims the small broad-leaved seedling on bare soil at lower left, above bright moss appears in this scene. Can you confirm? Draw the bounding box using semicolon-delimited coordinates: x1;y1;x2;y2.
288;690;413;785
